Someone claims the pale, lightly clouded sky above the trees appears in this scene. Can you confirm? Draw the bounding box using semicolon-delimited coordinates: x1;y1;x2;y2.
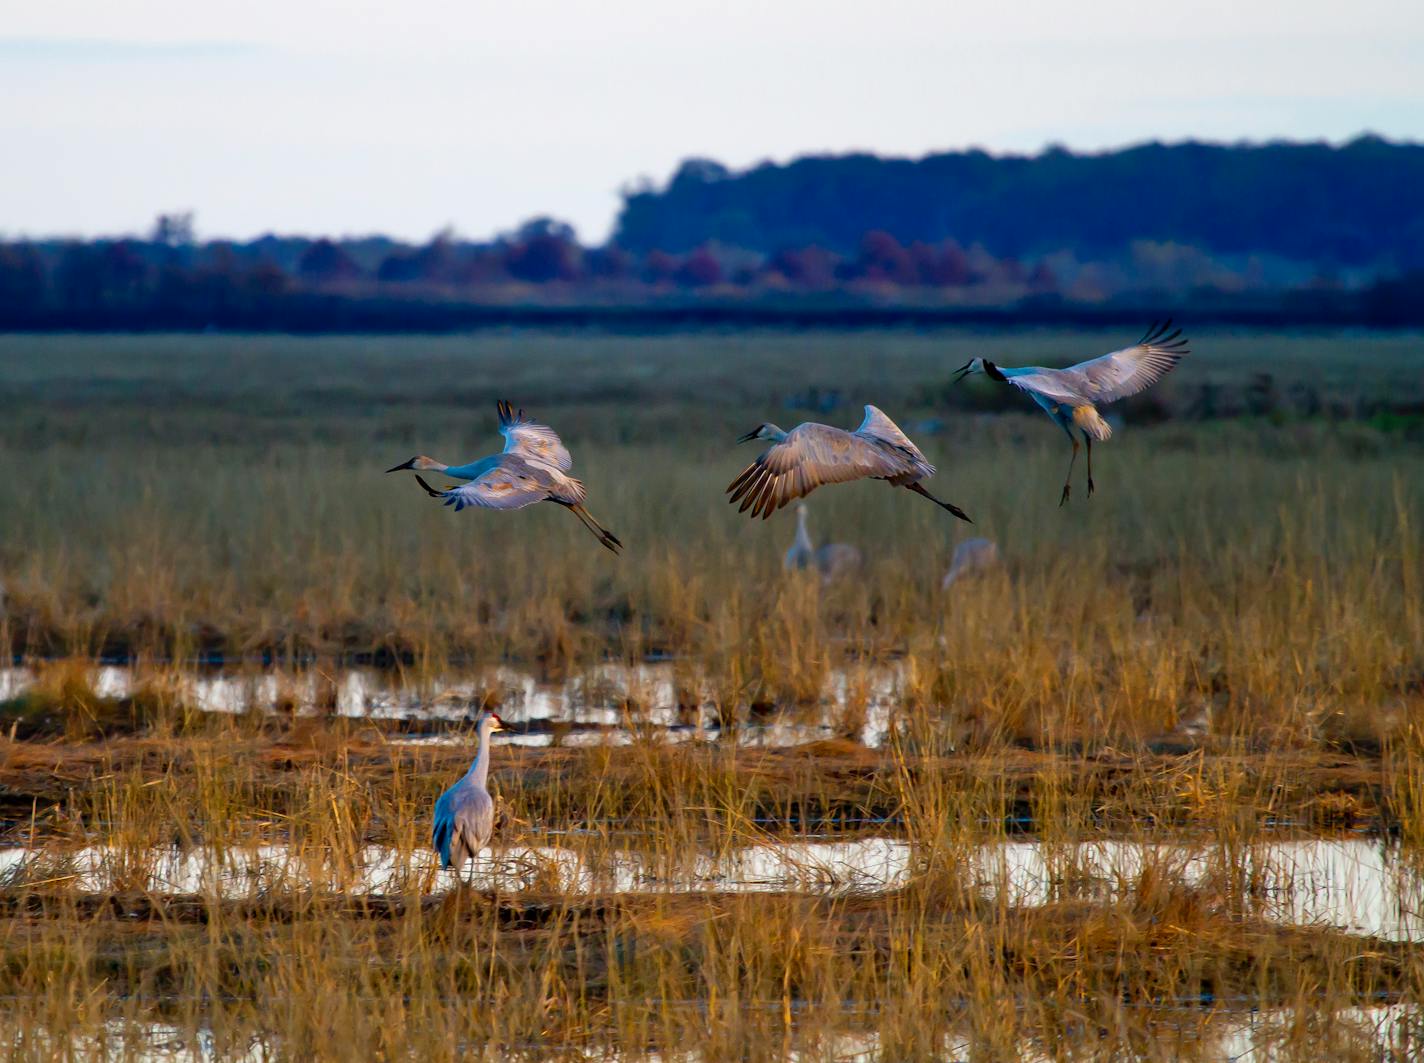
0;0;1424;239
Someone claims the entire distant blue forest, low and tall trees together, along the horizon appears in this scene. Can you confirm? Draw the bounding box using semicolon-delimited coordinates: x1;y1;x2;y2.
0;137;1424;331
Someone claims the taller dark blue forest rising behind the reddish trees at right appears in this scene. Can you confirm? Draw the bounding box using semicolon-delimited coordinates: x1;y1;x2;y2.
615;135;1424;269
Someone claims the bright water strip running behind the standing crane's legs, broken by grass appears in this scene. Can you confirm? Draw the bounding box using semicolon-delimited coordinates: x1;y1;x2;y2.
0;835;1424;940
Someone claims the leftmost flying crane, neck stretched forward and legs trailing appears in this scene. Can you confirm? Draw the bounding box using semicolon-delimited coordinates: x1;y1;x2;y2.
386;400;622;553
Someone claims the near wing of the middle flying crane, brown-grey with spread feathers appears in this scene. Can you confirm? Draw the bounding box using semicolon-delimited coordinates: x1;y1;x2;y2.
726;415;917;520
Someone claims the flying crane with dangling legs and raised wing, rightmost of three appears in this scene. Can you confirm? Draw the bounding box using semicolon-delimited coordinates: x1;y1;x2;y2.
954;321;1190;506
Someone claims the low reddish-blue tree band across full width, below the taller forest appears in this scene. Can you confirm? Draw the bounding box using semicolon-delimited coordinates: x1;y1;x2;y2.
0;221;1424;331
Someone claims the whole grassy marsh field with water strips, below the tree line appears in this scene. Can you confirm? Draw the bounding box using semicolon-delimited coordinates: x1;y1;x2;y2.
0;331;1424;1060
